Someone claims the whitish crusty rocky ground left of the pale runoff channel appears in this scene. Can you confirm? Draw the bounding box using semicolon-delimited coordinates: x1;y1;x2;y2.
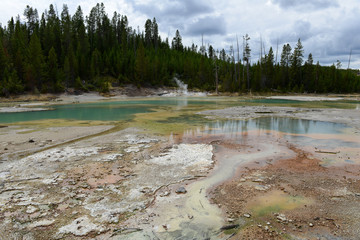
0;123;213;240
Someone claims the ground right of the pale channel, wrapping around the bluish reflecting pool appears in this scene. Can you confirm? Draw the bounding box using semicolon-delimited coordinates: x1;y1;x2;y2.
202;103;360;239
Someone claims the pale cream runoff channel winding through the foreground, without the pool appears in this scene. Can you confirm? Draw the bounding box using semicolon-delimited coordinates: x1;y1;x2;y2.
122;140;287;239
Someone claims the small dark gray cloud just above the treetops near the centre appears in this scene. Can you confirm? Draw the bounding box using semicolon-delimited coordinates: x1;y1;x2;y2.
185;16;226;36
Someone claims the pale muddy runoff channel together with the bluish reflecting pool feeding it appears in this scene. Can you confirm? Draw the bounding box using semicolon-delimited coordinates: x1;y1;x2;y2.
122;117;360;239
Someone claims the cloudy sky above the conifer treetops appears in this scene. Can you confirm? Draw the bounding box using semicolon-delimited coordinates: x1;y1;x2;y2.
0;0;360;69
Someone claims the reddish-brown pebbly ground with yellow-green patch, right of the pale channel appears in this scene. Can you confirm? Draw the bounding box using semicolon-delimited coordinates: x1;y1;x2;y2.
212;144;360;239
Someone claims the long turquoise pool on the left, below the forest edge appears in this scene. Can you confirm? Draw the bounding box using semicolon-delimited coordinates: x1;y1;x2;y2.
0;98;217;123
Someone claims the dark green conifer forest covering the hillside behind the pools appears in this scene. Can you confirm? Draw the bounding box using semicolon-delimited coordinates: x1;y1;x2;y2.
0;4;360;96
